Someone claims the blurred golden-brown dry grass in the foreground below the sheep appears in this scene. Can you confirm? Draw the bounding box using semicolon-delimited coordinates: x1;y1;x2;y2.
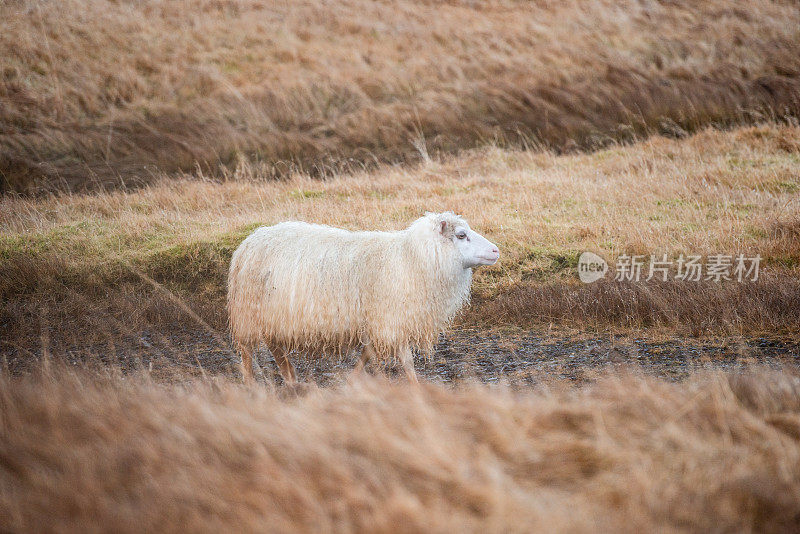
0;367;800;532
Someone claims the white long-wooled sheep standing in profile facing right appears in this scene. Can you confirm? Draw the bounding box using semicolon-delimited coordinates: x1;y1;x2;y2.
228;212;500;383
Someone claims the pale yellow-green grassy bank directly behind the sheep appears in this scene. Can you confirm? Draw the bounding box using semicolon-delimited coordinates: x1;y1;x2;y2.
0;126;800;350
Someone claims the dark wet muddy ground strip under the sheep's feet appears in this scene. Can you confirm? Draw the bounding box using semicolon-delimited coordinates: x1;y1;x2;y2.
2;329;800;386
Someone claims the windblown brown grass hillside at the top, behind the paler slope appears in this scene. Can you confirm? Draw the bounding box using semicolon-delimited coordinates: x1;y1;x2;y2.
0;0;800;192
